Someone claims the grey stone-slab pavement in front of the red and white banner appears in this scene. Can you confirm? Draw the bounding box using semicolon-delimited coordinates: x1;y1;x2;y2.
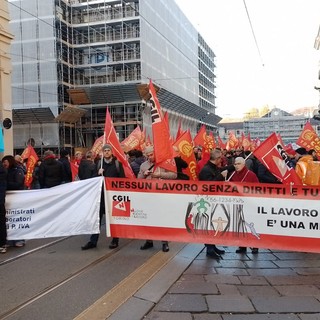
122;246;320;320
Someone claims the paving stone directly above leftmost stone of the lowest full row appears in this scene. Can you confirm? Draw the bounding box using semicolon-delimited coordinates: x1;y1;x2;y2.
169;279;218;294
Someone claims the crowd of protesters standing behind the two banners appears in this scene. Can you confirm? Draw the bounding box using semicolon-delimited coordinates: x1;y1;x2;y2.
0;144;319;259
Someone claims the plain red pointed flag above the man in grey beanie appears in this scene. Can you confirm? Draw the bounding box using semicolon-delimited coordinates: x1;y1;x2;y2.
104;108;135;178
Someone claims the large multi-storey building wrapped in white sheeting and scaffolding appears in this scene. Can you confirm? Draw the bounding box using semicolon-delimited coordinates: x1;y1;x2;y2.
9;0;220;154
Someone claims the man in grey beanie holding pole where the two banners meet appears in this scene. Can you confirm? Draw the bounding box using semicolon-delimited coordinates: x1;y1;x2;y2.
81;144;126;250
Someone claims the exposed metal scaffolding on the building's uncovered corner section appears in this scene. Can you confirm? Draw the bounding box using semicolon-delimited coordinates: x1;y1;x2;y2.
56;0;141;147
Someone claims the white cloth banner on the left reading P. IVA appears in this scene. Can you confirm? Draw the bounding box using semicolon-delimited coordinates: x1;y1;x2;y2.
6;177;103;240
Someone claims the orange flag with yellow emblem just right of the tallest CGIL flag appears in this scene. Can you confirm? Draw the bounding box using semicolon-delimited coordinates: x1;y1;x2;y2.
174;131;198;181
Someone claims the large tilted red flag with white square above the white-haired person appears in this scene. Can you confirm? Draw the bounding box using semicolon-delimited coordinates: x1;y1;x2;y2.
253;133;302;184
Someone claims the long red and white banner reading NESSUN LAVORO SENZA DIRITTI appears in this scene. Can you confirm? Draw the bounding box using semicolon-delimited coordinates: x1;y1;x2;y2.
106;179;320;252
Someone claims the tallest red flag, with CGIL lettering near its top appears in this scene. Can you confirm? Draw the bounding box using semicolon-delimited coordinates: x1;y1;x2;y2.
149;80;177;172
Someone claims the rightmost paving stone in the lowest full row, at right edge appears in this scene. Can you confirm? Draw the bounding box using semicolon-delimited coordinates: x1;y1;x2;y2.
251;296;320;313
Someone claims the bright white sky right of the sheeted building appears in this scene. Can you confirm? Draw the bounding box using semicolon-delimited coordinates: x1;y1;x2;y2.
176;0;320;117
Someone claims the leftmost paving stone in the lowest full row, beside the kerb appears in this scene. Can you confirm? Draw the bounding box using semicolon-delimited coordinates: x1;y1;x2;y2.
154;294;208;312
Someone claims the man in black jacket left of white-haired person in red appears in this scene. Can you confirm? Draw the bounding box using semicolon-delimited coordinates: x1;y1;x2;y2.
199;149;234;259
